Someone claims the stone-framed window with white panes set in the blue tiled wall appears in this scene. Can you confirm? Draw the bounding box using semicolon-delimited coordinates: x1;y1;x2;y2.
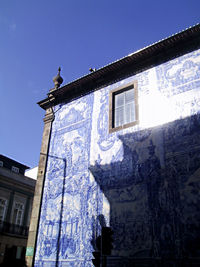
109;81;138;132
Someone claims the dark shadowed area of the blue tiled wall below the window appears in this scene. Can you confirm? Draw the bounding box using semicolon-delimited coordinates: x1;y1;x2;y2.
91;114;200;266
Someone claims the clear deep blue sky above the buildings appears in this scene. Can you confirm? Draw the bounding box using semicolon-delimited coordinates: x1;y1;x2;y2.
0;0;200;167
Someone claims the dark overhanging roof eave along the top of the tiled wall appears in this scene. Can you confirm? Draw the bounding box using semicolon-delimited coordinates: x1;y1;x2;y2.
38;24;200;109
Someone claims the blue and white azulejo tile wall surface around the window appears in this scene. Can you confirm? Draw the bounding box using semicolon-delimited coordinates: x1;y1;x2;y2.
35;50;200;267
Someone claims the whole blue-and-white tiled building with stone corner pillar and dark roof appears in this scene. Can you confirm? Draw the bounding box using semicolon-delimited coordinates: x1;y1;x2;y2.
26;25;200;267
